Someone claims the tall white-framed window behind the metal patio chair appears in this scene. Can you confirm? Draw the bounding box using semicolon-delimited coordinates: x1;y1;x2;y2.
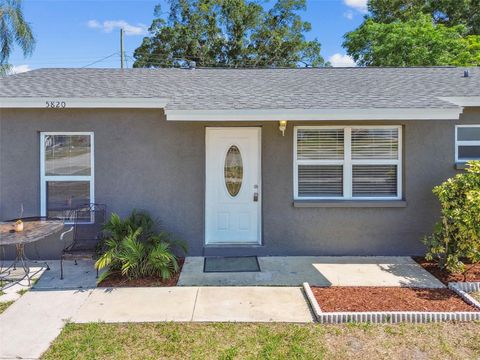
40;132;94;218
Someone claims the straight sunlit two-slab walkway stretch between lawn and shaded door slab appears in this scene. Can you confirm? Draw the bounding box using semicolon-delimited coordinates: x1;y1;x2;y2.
72;287;312;323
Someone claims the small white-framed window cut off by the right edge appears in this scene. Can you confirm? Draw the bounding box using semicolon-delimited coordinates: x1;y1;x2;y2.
455;125;480;163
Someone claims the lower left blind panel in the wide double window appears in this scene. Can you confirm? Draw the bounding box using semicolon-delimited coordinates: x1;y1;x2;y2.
298;165;343;197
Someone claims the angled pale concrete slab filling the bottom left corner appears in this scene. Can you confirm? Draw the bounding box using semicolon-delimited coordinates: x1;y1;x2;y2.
0;290;90;359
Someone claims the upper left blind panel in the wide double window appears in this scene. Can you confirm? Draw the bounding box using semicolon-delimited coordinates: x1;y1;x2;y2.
297;129;344;160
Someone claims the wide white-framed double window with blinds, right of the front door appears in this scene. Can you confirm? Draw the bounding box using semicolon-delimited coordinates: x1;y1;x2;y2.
294;126;402;200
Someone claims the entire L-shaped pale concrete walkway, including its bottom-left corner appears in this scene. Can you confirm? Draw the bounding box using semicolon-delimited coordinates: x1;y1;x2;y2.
0;287;313;359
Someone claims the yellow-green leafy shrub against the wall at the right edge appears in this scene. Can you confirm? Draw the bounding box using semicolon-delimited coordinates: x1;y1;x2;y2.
423;161;480;273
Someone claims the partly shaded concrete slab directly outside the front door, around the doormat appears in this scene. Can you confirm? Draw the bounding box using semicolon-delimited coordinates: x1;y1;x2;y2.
178;256;444;288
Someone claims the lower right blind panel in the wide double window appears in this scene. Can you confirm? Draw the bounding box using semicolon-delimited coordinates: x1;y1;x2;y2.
352;165;397;197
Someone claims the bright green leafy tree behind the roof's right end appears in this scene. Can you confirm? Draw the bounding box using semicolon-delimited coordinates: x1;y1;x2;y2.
343;14;480;66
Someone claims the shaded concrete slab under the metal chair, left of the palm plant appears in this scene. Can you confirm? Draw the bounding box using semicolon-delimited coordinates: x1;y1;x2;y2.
34;260;97;290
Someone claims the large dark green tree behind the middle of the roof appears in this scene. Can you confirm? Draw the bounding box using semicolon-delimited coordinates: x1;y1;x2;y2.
133;0;325;67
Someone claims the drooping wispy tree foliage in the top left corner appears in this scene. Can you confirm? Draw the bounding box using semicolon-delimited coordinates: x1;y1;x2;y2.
0;0;35;72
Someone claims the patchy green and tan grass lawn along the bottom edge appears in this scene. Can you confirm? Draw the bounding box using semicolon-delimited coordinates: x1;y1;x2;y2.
43;323;480;360
